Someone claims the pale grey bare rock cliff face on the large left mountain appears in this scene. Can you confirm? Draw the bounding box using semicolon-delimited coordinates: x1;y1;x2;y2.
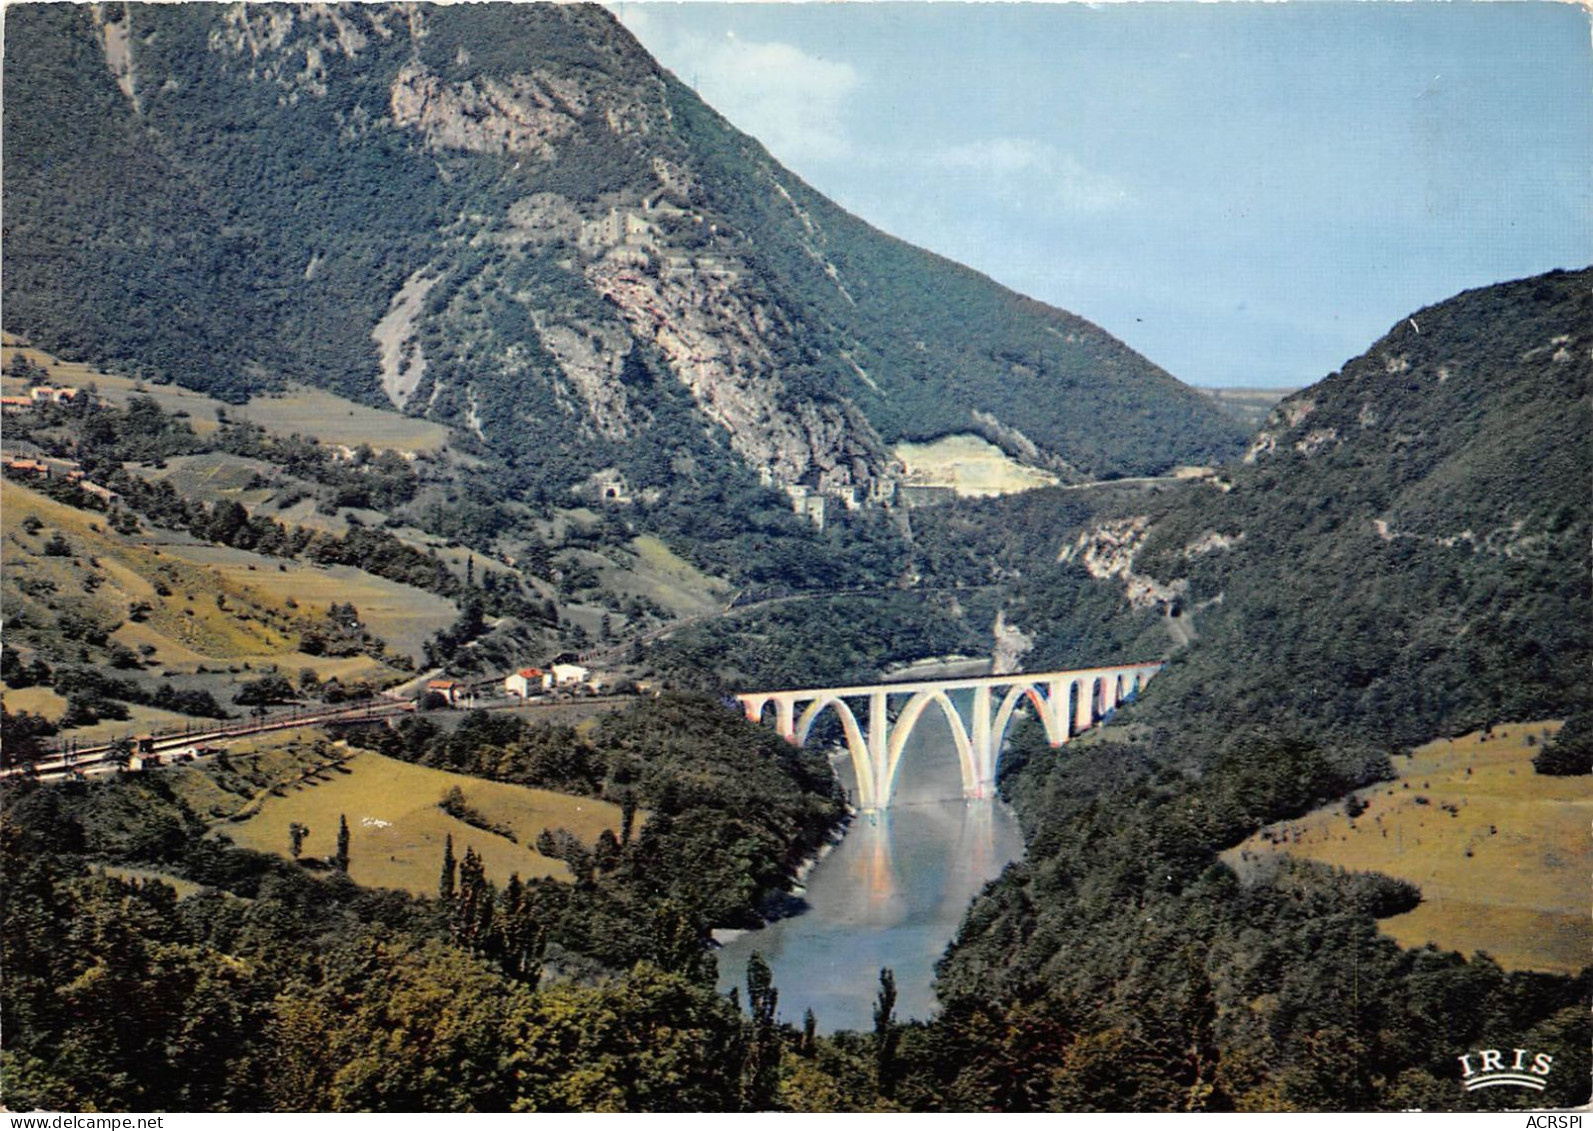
210;5;890;492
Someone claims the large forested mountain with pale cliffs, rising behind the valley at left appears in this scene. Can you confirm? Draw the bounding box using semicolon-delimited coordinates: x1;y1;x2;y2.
5;5;1241;512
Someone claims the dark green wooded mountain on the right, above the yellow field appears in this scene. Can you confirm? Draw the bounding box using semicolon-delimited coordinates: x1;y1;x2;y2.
1089;271;1593;758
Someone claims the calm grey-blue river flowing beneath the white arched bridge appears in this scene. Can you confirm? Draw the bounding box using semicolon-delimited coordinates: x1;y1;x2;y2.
718;691;1023;1032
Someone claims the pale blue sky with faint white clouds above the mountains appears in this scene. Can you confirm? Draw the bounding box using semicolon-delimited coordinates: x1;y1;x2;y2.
612;2;1593;385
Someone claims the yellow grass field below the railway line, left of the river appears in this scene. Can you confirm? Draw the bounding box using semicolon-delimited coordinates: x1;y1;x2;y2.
219;750;620;894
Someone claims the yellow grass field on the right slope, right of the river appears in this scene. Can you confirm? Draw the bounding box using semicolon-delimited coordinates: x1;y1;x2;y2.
1225;722;1593;973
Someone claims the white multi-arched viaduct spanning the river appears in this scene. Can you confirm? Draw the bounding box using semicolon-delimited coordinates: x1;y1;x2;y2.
736;663;1161;809
